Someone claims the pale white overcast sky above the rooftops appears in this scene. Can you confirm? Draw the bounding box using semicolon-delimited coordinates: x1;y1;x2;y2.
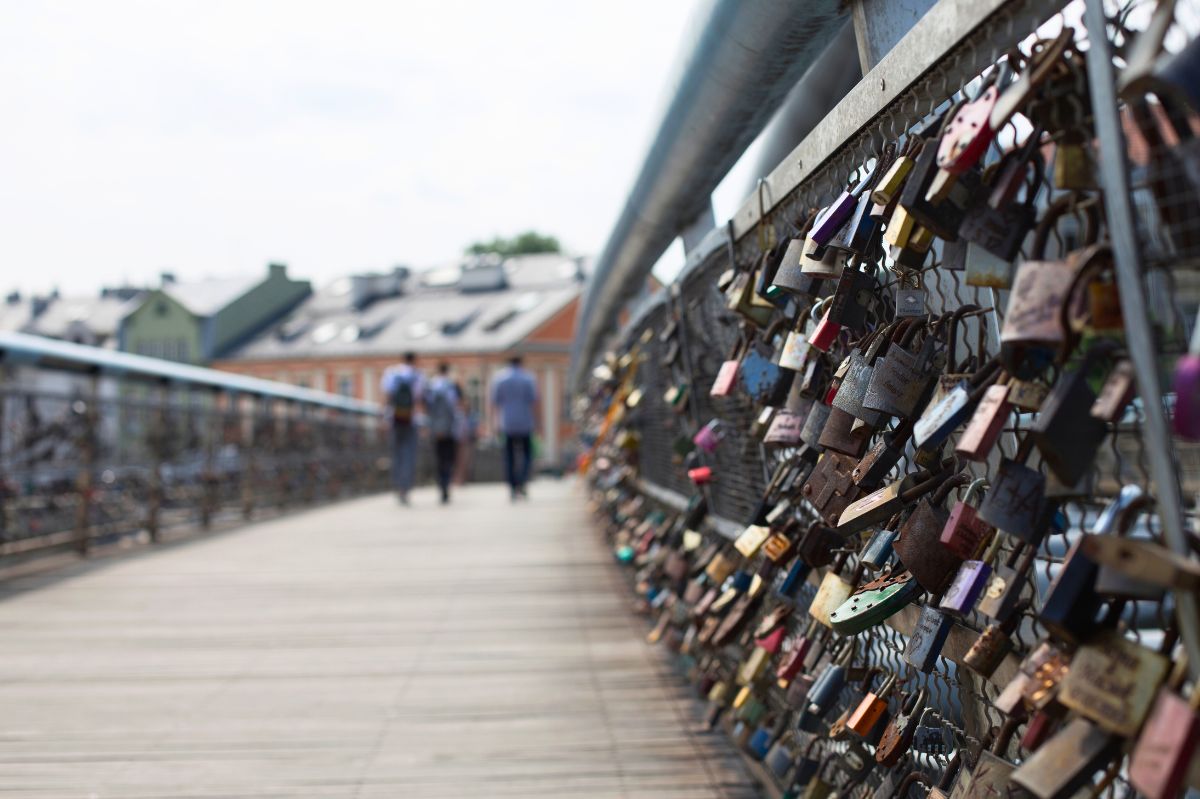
0;0;697;294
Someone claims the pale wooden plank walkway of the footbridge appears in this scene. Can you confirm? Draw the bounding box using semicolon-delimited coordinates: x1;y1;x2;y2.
0;481;756;799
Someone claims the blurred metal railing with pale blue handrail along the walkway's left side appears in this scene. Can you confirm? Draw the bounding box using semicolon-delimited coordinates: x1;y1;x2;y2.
0;334;388;565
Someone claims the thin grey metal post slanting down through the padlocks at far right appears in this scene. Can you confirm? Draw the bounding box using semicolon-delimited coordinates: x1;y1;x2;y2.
1084;0;1200;678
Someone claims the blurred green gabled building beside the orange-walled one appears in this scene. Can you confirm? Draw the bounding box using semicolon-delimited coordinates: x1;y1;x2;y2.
119;264;312;364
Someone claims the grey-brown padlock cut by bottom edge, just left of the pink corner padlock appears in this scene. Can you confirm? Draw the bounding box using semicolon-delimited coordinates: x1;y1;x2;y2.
1009;719;1120;799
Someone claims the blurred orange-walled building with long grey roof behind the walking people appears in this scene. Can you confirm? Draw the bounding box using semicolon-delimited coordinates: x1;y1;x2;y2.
212;254;586;465
